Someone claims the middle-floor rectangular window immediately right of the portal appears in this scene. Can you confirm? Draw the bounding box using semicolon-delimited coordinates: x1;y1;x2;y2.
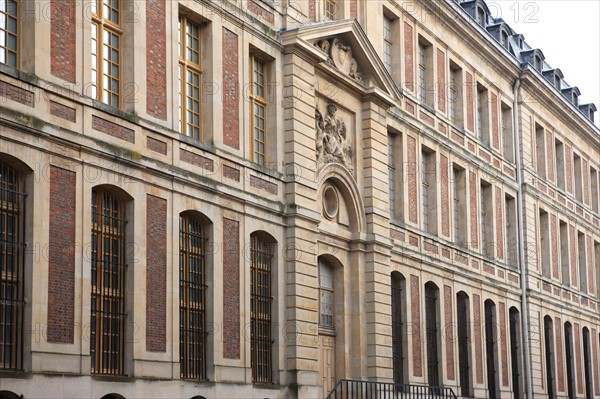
388;133;404;221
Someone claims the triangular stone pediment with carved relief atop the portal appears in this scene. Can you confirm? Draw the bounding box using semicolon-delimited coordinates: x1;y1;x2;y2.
281;19;402;104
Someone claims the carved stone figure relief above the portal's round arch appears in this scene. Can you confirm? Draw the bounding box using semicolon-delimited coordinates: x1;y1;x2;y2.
315;103;354;173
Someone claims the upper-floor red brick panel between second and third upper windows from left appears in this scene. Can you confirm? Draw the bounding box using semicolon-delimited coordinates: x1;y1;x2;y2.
146;0;167;120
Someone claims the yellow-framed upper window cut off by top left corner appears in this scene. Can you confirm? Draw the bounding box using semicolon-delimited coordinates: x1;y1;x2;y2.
0;0;19;67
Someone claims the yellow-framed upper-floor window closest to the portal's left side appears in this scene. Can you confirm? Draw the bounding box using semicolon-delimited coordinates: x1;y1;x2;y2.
250;56;267;166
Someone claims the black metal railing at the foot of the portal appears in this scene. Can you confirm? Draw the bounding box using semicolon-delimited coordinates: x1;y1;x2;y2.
327;380;457;399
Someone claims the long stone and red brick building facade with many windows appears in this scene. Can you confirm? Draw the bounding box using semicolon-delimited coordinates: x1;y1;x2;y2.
0;0;600;399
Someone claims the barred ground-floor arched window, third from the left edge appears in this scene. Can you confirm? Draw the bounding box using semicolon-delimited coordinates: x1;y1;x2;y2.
179;213;207;379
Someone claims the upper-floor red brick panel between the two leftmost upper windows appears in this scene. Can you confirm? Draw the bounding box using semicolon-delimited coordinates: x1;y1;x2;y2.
50;0;77;83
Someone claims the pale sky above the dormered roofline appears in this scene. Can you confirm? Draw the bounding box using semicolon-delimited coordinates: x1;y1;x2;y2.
487;0;600;126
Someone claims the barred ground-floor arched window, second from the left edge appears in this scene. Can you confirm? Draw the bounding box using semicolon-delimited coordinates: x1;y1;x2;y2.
90;188;127;375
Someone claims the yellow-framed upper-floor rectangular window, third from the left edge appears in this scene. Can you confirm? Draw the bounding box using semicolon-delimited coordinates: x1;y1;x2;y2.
178;16;202;140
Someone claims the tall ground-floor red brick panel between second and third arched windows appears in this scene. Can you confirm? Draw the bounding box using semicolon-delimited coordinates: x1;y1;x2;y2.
146;194;167;352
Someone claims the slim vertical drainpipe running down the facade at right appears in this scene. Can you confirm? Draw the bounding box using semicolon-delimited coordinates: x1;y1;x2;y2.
513;77;533;398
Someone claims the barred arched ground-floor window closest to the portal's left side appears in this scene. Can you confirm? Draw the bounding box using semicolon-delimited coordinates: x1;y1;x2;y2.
250;233;274;382
